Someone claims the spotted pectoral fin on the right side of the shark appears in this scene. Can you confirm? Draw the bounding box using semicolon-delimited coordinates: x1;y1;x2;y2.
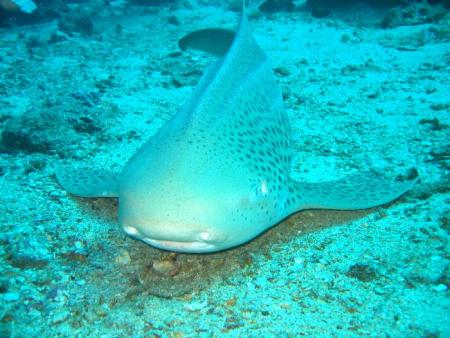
286;169;419;214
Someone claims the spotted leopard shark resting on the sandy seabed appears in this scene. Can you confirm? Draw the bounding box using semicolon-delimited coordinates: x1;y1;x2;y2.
57;1;417;253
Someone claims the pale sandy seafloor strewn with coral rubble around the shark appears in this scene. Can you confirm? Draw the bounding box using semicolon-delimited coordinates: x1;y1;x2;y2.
0;1;450;337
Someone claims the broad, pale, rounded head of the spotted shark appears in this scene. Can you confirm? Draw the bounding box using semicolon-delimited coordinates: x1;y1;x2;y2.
119;149;276;253
